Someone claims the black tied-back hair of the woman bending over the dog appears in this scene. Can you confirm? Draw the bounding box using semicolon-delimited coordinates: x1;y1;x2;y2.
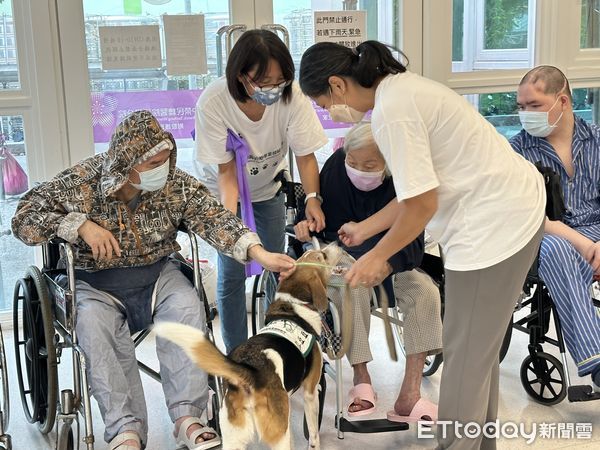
299;41;408;97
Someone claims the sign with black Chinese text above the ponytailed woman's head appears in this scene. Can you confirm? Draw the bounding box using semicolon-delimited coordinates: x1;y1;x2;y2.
314;11;367;48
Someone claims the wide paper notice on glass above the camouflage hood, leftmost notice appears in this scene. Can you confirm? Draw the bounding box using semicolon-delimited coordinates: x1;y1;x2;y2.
98;25;162;70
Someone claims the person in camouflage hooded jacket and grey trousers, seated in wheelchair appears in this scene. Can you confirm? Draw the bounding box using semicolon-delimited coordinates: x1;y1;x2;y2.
12;111;293;450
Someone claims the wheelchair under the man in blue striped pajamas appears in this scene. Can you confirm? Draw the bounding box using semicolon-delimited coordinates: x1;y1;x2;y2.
501;255;600;406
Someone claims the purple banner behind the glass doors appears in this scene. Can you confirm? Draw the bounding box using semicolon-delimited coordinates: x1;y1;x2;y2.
91;89;352;143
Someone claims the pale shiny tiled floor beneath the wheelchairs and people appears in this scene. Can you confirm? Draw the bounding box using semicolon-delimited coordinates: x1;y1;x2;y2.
4;308;600;450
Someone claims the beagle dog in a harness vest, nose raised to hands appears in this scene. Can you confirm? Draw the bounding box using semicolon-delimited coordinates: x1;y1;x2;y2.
154;244;341;450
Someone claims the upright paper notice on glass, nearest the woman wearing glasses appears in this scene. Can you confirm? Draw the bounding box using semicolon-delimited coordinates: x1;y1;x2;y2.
162;14;208;76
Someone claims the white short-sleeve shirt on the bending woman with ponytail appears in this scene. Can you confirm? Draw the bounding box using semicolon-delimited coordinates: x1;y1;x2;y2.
372;72;546;271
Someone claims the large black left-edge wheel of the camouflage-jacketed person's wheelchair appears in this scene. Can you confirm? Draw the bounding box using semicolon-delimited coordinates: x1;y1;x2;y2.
13;266;58;434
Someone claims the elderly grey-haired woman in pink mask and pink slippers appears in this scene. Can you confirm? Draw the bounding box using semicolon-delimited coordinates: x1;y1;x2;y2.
295;123;442;422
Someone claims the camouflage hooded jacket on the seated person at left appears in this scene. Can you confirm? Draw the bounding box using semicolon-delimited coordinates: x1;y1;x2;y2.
12;111;260;270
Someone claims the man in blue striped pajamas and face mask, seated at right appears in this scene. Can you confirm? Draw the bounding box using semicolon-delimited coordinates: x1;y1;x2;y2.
510;66;600;389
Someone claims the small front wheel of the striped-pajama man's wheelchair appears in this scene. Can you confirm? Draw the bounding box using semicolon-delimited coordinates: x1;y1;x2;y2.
521;352;567;406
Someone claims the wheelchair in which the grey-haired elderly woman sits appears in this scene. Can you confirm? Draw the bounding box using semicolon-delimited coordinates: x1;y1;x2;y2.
251;172;444;439
